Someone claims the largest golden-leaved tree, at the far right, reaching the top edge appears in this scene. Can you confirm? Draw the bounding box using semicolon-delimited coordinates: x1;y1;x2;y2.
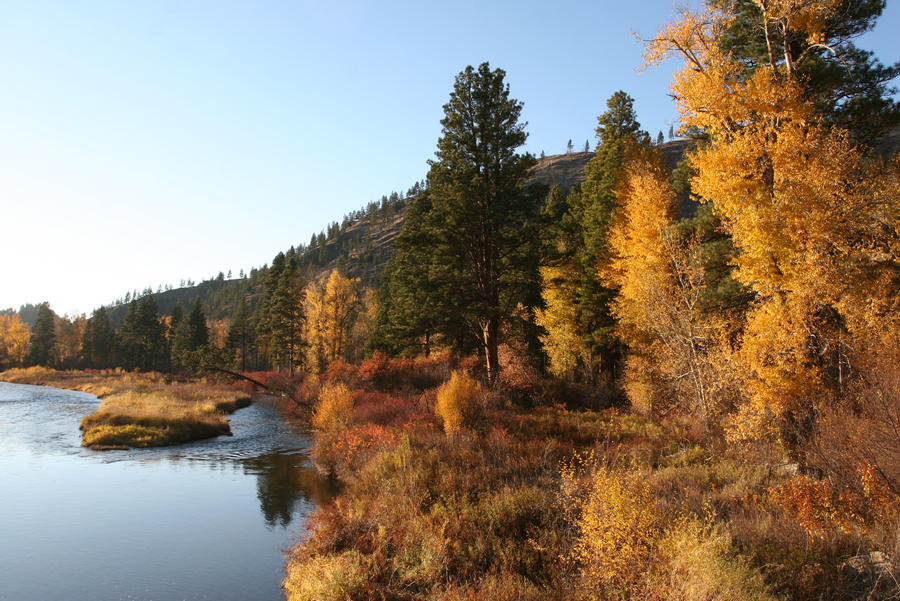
645;0;898;443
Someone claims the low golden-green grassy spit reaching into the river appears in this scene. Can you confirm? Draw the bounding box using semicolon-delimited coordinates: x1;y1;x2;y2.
0;368;250;449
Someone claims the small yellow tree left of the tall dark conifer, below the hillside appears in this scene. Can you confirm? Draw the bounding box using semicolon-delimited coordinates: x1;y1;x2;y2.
303;270;359;371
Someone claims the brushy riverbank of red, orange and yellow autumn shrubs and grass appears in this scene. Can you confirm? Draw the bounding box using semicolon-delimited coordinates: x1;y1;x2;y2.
284;358;898;601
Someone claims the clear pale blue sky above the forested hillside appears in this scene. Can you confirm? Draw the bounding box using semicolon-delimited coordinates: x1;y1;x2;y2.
0;0;900;313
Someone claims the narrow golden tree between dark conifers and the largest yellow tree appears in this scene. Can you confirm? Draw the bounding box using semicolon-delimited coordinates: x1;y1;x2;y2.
601;150;732;423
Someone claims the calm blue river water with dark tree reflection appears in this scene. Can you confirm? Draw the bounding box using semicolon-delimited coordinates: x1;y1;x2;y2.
0;382;330;601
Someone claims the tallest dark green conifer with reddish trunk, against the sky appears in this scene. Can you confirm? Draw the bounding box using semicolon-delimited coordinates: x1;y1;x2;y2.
420;63;538;379
